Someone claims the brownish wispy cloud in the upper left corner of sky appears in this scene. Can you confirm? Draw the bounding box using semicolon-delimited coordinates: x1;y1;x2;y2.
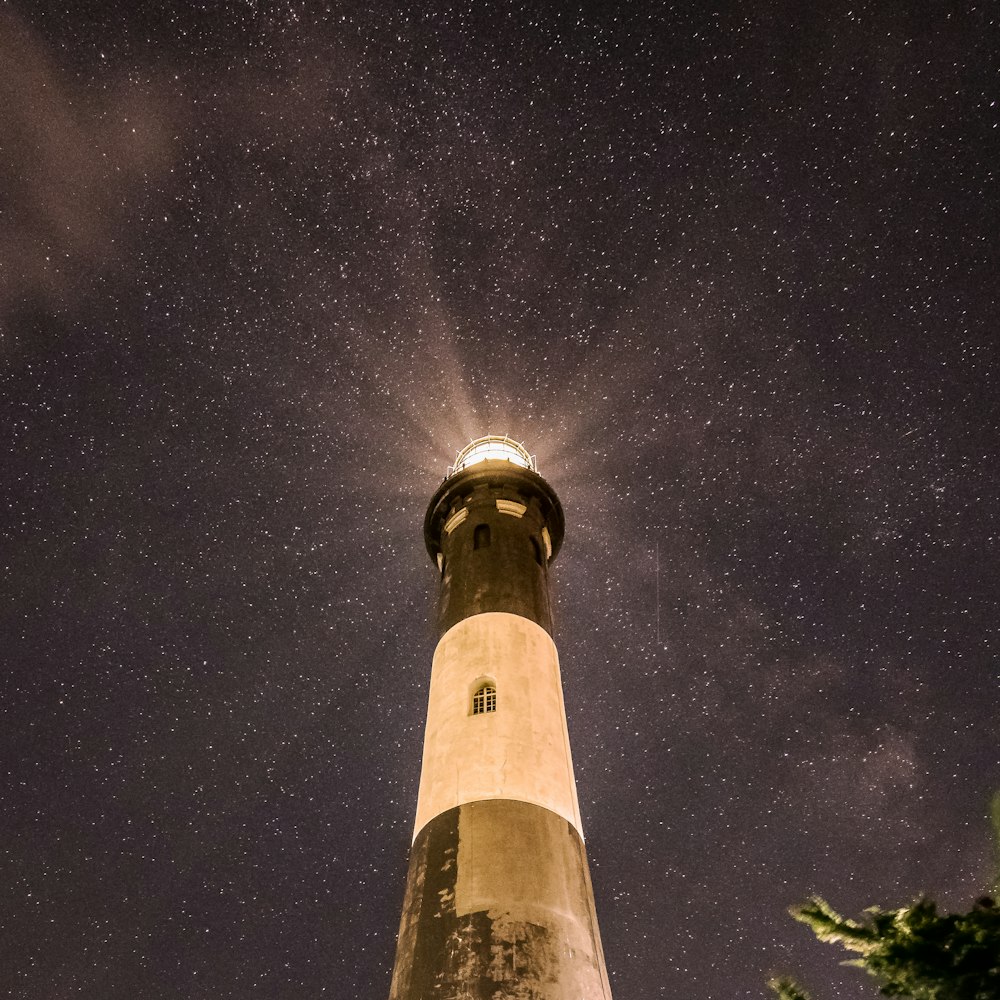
0;13;173;317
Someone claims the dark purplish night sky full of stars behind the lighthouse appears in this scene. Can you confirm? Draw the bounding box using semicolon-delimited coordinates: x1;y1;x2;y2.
0;0;1000;1000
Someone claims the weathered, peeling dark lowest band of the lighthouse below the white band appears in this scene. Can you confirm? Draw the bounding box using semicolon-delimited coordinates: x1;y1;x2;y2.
389;800;611;1000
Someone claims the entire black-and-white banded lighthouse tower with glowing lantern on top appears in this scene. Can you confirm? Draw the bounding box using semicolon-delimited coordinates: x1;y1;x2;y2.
389;437;611;1000
